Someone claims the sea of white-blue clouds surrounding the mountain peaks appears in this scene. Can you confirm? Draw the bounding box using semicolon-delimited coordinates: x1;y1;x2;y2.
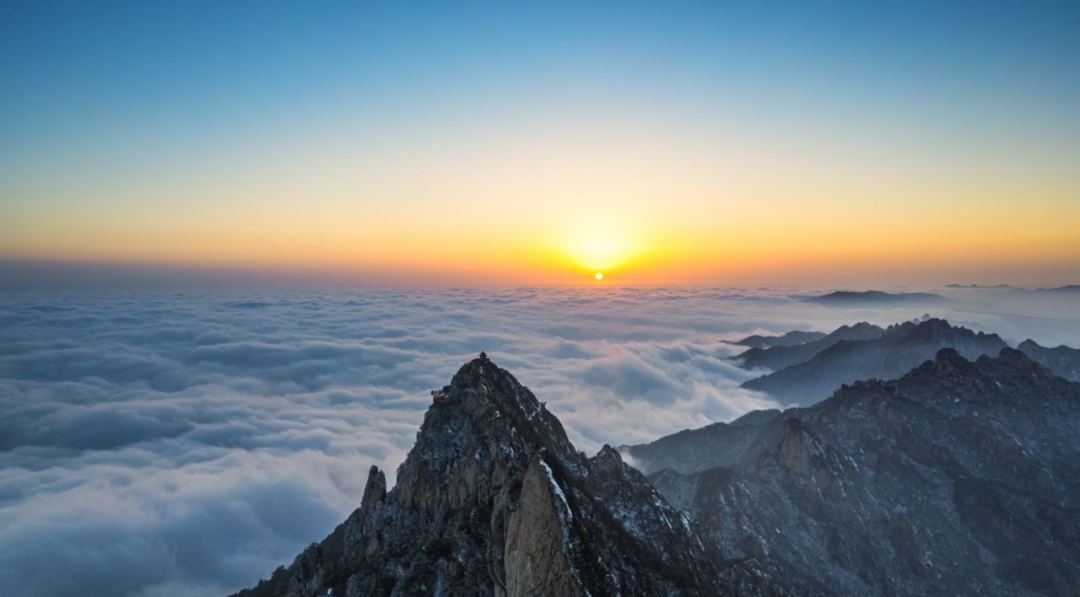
0;287;1080;597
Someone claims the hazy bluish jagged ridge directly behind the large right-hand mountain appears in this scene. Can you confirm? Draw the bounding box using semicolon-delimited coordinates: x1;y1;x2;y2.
742;318;1008;405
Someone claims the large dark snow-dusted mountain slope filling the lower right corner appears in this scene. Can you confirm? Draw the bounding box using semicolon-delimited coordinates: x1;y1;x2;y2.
649;349;1080;597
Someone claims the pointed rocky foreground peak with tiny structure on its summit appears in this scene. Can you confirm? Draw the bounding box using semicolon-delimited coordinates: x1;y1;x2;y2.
227;357;780;597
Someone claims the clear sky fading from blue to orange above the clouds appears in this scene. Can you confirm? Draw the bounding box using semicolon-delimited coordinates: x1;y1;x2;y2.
0;1;1080;285
